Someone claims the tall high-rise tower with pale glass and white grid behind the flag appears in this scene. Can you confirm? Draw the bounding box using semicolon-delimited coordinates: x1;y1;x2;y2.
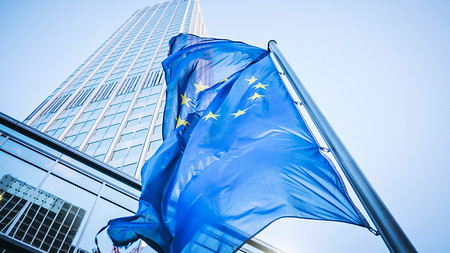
25;0;206;177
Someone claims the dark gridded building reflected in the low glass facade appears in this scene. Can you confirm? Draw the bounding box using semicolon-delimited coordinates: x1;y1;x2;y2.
0;174;86;252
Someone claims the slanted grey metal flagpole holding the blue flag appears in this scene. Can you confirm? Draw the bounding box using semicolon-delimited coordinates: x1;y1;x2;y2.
268;40;417;252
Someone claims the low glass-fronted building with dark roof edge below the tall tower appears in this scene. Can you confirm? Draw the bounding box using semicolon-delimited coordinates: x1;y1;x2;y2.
0;114;154;252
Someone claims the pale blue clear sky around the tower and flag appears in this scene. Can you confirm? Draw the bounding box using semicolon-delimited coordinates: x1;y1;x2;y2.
0;0;450;252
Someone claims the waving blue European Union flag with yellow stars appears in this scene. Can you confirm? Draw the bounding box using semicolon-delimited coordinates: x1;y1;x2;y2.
108;34;369;252
